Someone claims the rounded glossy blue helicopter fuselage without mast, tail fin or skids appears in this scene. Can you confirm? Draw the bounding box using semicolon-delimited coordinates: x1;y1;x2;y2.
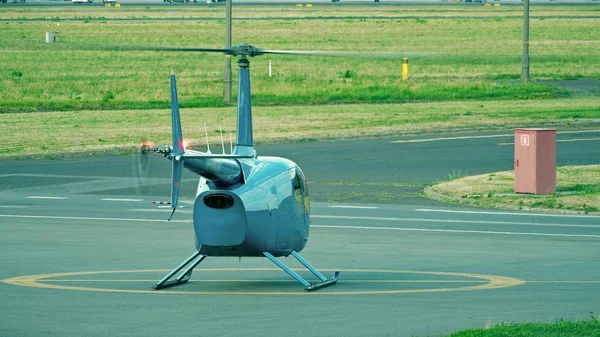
184;157;310;256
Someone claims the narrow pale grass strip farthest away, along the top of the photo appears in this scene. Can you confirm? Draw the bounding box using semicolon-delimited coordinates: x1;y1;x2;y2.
0;3;600;21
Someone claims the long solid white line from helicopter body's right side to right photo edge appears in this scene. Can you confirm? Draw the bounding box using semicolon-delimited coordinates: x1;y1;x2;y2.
311;215;600;229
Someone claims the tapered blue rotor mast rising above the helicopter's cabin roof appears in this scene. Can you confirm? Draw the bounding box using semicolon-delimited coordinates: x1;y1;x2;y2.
234;57;256;156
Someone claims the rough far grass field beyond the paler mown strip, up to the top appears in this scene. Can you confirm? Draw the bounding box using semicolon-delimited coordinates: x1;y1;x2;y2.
0;6;600;113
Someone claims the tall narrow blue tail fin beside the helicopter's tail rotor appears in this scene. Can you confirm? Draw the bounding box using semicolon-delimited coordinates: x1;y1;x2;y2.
169;74;184;211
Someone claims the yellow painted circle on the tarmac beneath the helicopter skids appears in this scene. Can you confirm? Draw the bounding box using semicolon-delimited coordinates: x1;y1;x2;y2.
2;268;525;296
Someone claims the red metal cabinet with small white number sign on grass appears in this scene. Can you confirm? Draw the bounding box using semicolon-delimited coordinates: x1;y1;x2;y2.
514;129;556;194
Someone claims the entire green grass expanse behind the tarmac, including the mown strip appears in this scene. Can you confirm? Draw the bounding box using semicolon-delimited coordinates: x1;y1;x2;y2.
0;6;600;157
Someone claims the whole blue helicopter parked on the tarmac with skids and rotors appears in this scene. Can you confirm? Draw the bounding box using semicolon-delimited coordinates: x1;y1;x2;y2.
141;44;339;291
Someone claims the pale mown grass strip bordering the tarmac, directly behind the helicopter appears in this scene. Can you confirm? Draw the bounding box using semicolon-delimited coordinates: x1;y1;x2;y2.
0;97;600;156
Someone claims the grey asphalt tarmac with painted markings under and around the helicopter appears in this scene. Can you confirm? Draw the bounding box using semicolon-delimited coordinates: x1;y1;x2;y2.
0;125;600;337
